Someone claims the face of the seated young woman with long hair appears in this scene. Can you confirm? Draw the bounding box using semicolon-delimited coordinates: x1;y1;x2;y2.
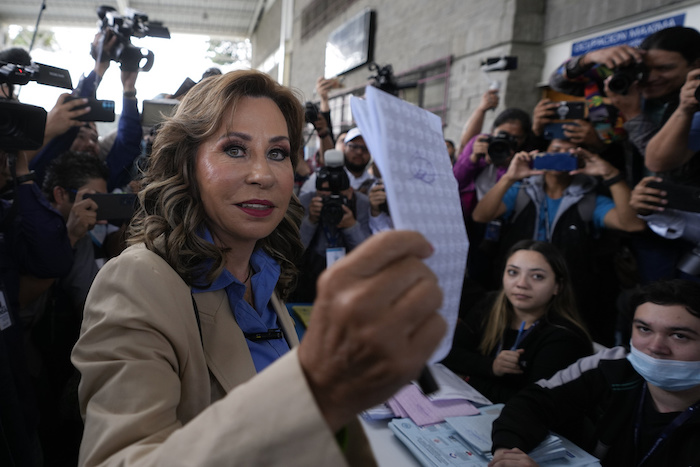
503;250;559;313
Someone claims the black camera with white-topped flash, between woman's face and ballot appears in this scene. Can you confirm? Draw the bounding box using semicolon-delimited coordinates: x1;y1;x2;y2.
316;149;350;227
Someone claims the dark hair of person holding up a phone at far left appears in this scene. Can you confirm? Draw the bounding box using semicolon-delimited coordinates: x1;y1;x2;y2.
42;151;109;203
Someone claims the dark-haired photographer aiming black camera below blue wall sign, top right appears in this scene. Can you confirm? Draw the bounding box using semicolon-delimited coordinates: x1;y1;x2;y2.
550;26;700;183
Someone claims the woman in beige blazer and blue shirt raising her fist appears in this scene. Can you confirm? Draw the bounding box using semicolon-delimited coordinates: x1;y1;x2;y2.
73;71;445;466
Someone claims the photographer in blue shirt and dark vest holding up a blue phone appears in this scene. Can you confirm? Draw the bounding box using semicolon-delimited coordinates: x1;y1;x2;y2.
473;139;645;345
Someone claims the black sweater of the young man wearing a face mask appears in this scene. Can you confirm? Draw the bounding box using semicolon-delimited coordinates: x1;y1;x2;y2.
492;347;700;467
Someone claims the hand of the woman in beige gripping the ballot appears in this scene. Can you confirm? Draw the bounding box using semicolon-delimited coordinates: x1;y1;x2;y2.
299;231;446;430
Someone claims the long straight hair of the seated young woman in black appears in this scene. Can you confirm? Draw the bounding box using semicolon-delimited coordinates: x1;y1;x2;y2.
479;240;591;355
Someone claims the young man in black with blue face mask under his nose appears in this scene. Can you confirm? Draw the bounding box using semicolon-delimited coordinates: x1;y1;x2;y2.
489;279;700;467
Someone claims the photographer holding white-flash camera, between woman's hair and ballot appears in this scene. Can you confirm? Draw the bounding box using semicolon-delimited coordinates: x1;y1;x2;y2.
290;162;372;302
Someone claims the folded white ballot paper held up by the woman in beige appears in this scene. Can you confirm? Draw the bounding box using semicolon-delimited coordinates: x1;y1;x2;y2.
350;86;469;362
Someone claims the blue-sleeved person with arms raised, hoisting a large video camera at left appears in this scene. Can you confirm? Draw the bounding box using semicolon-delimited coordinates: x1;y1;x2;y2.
30;30;142;191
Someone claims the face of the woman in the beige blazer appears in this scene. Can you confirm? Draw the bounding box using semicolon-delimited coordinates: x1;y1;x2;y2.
195;97;294;252
